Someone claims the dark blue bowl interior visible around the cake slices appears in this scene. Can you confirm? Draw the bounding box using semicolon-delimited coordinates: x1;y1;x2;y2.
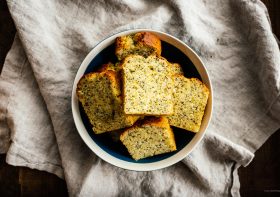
79;41;201;163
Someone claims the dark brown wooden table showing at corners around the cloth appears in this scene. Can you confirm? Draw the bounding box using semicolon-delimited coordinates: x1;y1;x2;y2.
0;0;280;196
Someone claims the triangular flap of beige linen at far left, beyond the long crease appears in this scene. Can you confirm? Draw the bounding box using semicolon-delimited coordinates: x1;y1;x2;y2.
0;35;63;178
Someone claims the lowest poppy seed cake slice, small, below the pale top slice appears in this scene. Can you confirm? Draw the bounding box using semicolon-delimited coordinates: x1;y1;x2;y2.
120;117;177;160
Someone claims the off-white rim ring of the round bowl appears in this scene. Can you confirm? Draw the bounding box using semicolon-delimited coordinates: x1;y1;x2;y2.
71;28;213;171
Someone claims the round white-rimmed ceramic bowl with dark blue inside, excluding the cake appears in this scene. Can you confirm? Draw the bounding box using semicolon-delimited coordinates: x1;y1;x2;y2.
72;29;212;171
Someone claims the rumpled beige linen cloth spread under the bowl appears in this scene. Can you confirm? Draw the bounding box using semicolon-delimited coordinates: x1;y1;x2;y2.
0;0;280;197
